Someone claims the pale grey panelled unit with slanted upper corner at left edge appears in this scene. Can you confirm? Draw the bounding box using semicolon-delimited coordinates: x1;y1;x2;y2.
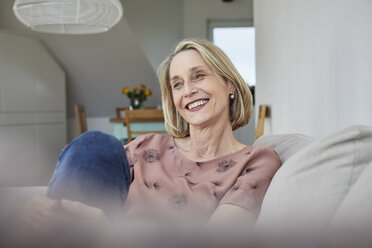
0;31;66;186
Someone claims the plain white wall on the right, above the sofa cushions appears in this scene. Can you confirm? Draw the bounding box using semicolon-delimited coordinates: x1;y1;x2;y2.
254;0;372;136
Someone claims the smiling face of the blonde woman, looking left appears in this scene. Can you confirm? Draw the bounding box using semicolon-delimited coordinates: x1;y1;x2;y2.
169;49;234;128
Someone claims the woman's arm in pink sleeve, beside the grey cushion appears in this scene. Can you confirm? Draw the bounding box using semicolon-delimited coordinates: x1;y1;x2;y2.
207;147;280;229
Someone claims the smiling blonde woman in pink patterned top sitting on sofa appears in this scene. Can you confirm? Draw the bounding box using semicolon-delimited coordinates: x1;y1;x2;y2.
16;40;280;240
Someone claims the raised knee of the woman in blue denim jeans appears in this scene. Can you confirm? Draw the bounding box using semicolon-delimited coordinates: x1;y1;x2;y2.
47;131;130;218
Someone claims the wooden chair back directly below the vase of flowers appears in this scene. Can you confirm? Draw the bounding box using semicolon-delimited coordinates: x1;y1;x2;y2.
125;109;167;142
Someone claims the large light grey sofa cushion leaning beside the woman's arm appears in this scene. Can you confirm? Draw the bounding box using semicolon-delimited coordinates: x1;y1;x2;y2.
256;126;372;230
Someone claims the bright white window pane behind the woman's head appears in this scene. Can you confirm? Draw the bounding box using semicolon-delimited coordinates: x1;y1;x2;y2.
213;27;256;86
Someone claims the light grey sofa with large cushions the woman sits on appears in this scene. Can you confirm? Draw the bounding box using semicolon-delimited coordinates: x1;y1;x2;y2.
0;126;372;242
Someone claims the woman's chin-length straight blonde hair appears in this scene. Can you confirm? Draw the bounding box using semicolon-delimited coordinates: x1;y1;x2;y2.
158;39;252;137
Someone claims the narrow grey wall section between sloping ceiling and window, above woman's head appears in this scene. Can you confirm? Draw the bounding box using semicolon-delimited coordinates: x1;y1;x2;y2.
122;0;183;71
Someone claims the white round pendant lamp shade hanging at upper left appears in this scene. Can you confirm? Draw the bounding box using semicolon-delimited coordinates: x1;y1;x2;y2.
13;0;123;34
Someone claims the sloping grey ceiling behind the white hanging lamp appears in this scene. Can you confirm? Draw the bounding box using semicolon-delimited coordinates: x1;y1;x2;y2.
0;1;160;117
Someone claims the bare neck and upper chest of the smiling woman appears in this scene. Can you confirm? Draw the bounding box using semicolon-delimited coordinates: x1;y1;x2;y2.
176;123;245;162
